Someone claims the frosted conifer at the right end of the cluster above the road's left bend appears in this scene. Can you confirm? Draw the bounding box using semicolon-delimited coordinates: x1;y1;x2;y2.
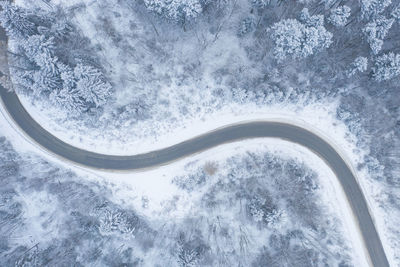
74;63;112;107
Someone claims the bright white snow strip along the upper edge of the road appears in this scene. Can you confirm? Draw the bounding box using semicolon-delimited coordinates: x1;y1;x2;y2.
19;95;354;156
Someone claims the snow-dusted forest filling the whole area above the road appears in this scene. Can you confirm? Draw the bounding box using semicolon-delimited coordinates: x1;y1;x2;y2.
0;0;400;262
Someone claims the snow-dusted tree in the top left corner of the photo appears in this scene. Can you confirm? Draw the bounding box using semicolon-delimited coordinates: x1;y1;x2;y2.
0;1;36;38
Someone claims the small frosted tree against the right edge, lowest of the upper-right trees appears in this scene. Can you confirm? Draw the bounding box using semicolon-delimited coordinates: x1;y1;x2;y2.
372;53;400;81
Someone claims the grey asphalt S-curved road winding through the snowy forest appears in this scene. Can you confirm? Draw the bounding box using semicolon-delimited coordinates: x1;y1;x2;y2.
0;28;389;267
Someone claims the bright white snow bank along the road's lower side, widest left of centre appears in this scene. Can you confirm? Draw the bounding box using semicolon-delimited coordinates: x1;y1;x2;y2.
77;138;367;266
